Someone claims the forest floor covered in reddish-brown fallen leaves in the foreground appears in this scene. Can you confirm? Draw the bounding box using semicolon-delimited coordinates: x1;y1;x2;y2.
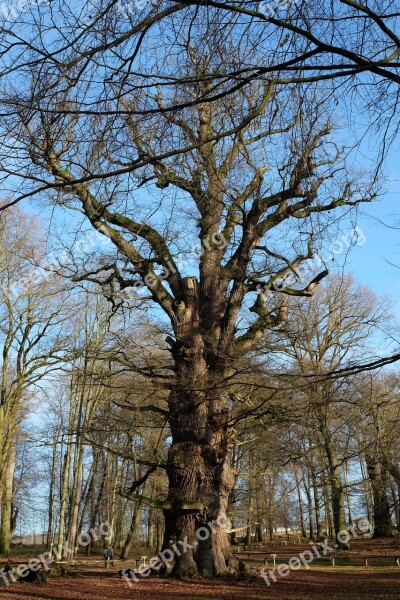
0;540;400;600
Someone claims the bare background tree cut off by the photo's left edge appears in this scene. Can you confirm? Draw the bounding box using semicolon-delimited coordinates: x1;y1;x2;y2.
0;209;68;554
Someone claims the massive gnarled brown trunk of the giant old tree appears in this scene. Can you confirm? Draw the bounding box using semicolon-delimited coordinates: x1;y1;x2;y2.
163;278;238;577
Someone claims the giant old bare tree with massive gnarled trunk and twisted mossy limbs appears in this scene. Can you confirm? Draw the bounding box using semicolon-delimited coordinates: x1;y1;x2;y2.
0;8;378;575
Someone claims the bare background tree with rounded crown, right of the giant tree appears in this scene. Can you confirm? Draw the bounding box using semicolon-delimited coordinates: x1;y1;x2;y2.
276;276;388;547
